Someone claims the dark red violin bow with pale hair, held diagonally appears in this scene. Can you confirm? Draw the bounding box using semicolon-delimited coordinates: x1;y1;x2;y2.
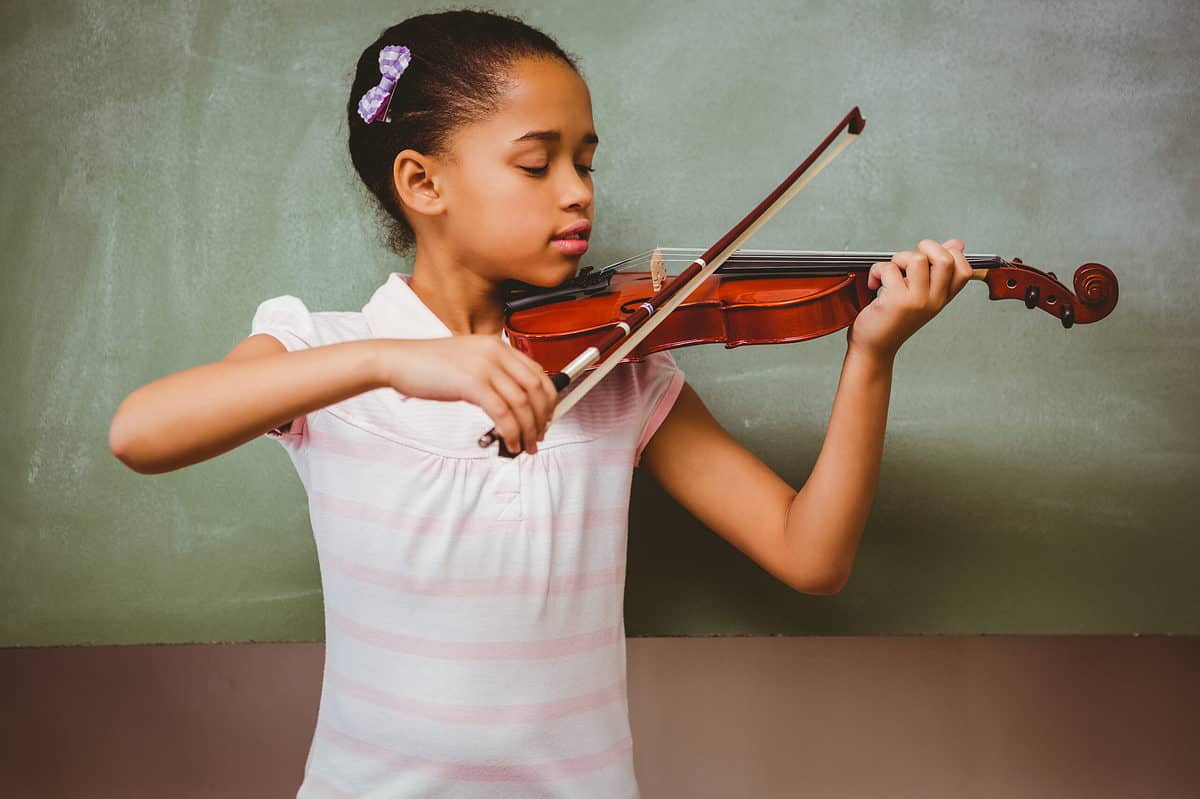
479;106;866;457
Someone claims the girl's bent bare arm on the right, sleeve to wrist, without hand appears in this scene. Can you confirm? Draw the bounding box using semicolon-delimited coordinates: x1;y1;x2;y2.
642;350;892;594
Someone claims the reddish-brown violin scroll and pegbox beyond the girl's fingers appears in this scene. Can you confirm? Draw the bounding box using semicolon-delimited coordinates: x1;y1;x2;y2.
984;258;1118;328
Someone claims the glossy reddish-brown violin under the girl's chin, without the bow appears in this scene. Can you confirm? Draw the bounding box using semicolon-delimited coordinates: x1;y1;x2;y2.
504;248;1117;373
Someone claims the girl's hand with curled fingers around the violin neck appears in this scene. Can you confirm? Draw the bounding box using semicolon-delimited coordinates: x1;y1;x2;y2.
846;239;971;359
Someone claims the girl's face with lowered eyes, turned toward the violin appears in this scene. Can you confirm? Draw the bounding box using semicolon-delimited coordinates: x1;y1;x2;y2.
439;59;598;286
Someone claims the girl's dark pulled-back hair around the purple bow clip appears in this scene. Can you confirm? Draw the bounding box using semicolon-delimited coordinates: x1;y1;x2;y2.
346;10;580;254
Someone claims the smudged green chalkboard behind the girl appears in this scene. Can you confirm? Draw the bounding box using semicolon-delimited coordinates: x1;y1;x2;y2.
0;0;1200;645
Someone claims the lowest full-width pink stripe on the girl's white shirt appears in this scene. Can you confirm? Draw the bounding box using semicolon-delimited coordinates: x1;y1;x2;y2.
318;725;634;782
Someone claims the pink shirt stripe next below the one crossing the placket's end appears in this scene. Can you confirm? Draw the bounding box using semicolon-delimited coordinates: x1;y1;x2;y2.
322;551;625;596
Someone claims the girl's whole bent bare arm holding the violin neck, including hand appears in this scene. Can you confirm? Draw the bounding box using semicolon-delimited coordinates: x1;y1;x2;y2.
642;239;971;594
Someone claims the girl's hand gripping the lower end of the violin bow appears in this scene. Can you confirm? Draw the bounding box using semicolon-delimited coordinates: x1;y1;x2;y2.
379;336;558;455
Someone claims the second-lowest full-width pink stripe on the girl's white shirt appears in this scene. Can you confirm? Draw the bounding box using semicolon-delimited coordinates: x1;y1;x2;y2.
328;671;625;725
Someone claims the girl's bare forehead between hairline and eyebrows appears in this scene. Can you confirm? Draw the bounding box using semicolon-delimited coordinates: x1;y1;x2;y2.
462;59;594;148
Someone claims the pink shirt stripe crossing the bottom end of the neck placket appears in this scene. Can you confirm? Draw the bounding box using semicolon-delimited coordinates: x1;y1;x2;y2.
308;488;629;535
